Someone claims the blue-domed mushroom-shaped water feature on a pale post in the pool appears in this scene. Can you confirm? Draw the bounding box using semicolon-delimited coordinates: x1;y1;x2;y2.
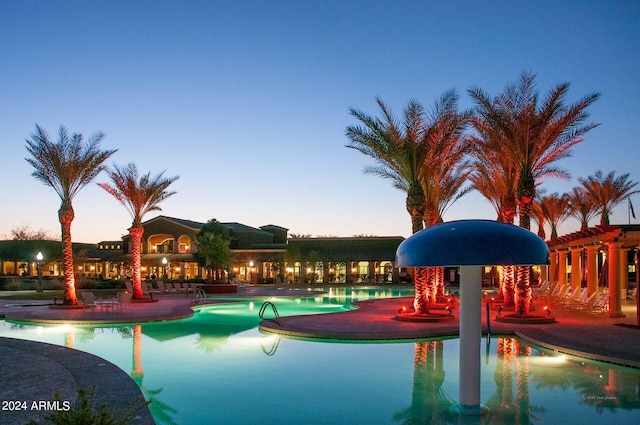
396;220;549;415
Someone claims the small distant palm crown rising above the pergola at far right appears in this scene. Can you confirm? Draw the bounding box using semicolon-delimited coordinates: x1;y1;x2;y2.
578;170;638;225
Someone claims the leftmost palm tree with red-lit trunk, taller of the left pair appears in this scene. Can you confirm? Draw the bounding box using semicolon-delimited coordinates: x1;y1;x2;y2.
26;125;116;305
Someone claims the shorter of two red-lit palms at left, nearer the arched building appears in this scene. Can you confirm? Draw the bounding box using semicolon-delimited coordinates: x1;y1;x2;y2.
98;163;179;299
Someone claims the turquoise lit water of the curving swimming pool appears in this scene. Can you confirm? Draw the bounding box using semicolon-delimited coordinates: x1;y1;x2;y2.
0;288;640;425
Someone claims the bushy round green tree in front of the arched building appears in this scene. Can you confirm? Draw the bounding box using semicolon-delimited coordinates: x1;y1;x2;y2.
195;219;233;282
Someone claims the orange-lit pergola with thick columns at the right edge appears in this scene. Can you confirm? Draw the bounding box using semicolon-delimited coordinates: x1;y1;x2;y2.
541;224;640;317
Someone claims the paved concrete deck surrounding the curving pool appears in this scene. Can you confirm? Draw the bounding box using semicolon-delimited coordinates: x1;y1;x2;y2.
0;287;640;424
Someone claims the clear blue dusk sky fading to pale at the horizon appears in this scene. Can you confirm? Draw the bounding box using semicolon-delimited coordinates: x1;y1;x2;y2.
0;0;640;242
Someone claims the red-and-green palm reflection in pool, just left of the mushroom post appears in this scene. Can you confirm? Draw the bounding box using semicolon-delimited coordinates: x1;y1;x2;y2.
393;341;457;425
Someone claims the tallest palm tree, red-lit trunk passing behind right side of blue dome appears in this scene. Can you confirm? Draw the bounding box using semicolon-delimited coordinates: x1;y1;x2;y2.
469;72;600;315
